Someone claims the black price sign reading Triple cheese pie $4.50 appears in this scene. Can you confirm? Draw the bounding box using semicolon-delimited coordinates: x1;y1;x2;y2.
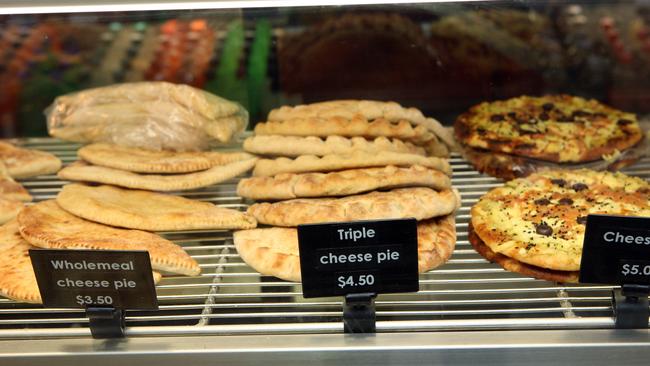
298;219;419;297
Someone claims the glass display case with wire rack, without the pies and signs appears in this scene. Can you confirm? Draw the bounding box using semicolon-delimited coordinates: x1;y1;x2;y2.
0;0;650;365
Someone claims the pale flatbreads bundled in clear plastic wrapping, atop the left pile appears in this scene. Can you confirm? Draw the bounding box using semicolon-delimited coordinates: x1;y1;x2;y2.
45;82;248;151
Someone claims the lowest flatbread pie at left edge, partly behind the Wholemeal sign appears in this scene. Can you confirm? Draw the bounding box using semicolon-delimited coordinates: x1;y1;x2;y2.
0;220;162;304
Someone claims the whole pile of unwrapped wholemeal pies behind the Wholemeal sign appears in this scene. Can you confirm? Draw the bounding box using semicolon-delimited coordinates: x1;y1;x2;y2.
0;144;264;303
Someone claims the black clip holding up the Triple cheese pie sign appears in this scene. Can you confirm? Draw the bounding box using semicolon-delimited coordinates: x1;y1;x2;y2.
343;293;377;333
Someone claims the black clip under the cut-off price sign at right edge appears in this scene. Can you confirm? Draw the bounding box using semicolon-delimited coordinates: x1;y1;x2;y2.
612;284;650;329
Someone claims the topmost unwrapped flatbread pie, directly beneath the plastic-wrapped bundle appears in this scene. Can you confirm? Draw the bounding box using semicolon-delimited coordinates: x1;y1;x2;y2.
77;143;253;173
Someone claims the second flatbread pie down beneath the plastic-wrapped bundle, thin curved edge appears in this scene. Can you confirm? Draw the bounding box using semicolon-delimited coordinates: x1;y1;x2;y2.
58;158;257;191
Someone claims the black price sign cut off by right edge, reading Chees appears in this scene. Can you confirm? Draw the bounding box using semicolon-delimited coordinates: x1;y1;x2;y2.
580;215;650;285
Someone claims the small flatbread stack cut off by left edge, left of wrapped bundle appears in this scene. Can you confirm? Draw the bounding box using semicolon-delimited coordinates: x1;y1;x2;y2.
0;141;61;224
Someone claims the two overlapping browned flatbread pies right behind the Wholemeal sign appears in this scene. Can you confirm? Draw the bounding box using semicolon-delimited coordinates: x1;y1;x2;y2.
0;200;201;304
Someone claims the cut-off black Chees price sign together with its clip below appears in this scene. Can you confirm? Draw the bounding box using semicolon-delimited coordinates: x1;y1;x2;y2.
580;215;650;329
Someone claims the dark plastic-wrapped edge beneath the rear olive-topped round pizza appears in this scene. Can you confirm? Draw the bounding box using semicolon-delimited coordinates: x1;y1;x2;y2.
459;121;650;180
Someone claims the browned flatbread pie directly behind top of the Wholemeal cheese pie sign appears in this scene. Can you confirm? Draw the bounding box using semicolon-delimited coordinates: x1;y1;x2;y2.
18;200;201;276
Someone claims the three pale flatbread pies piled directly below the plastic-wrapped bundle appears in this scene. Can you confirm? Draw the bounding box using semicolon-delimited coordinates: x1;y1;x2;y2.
56;143;257;231
